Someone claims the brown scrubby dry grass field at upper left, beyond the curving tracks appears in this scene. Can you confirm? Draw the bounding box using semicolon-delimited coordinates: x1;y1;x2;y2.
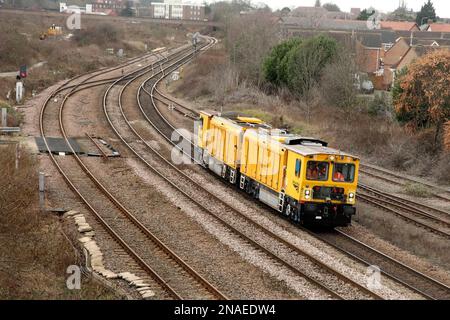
0;11;189;103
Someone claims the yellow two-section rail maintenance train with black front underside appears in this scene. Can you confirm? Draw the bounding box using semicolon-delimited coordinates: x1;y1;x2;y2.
195;111;359;227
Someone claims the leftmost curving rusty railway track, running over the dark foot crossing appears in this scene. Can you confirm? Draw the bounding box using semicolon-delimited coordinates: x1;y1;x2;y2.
40;47;226;299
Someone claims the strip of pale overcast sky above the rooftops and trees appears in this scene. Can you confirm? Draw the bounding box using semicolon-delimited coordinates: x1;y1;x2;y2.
209;0;450;18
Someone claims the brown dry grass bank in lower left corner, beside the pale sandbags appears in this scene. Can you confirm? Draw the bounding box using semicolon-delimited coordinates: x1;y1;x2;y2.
0;146;115;299
